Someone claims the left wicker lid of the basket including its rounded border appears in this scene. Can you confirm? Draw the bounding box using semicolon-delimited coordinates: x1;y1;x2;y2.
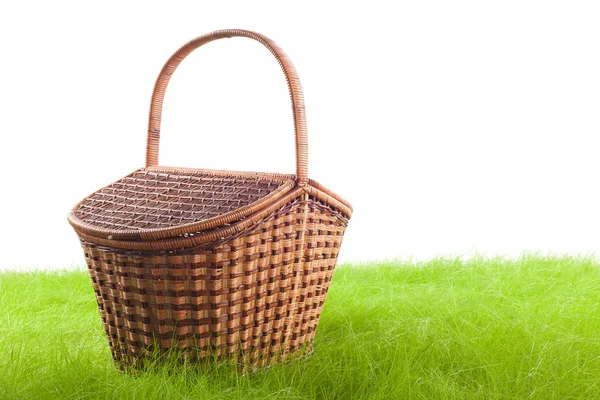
69;167;295;240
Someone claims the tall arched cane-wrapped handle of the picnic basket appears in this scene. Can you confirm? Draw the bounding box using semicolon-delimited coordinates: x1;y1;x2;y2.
146;29;308;186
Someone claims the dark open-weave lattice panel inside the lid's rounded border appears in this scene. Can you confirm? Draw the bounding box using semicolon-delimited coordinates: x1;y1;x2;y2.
75;170;282;230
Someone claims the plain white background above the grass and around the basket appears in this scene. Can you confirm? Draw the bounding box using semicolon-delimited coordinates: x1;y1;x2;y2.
0;1;600;269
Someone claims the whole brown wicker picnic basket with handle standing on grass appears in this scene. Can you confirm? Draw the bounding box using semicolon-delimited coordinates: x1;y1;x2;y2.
69;30;352;369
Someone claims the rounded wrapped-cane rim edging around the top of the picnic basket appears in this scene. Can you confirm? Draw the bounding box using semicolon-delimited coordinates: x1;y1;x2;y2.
68;166;352;243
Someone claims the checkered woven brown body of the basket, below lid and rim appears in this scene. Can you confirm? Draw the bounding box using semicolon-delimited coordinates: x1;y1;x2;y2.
81;196;347;367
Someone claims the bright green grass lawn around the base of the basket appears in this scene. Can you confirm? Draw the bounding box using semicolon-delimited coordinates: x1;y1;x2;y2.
0;256;600;400
